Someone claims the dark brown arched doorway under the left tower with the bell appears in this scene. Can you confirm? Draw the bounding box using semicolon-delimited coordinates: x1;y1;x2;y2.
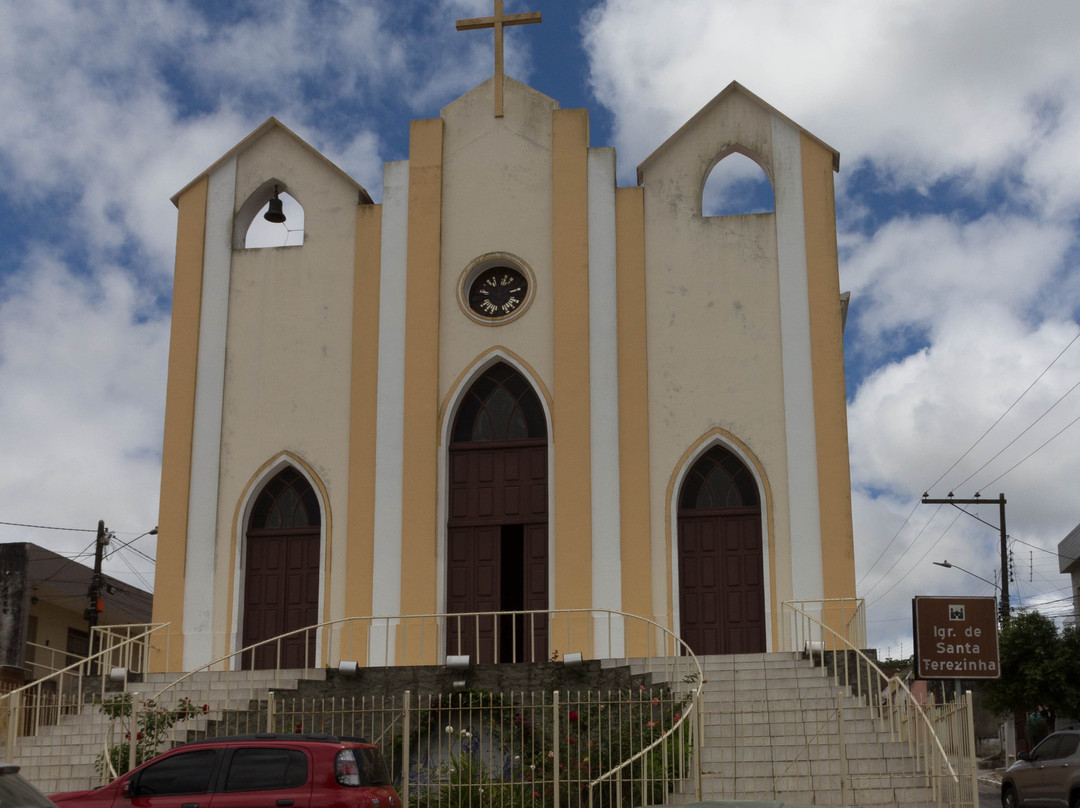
242;467;322;669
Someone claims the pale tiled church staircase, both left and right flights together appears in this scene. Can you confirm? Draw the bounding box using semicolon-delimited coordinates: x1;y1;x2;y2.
8;652;950;808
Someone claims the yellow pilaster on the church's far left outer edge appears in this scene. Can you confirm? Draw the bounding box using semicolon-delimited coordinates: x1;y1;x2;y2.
150;177;210;671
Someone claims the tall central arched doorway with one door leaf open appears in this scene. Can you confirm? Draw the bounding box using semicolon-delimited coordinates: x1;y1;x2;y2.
446;362;548;662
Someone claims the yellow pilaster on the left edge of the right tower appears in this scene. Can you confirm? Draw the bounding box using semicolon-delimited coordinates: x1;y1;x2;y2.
615;188;652;657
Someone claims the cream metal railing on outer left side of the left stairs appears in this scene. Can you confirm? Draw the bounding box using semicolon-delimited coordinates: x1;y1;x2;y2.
0;623;168;755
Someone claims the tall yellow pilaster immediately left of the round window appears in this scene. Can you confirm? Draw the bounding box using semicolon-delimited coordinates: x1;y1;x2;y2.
399;118;443;663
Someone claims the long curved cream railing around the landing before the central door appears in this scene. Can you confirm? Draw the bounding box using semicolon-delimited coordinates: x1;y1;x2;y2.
135;609;703;808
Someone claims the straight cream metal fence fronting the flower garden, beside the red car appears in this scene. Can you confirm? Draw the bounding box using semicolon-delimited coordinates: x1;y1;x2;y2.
118;677;699;808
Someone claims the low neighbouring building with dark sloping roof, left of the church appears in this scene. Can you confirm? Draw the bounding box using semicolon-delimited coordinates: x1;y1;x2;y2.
0;542;153;687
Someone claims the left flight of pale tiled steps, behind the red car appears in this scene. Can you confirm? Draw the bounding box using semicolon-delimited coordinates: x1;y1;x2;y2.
0;668;326;794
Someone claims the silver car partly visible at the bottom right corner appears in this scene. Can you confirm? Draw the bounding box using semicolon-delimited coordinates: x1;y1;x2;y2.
1001;727;1080;808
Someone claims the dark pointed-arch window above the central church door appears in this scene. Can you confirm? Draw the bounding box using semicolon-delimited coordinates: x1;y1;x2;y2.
453;362;548;443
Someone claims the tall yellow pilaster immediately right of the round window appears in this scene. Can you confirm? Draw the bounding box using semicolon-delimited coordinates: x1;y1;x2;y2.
552;109;596;617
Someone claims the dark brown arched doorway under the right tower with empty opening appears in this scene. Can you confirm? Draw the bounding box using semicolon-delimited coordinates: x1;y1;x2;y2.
678;446;766;655
